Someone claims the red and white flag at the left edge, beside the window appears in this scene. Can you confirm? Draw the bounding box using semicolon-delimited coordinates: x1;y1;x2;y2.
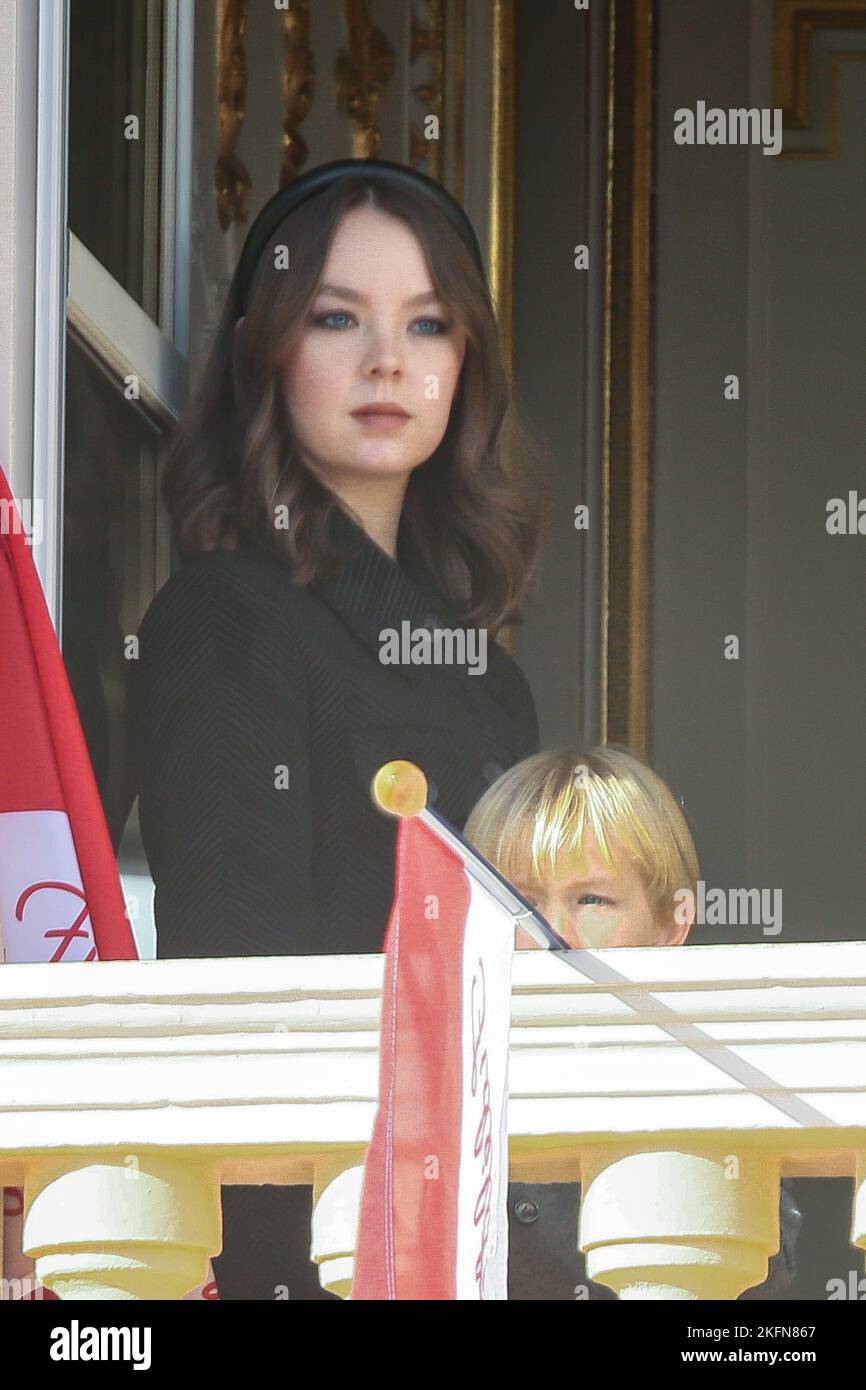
0;468;138;1298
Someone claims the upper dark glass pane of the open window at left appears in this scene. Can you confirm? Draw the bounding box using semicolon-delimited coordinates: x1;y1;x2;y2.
70;0;163;322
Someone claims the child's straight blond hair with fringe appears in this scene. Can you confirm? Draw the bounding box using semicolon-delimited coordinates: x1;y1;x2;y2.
463;745;699;913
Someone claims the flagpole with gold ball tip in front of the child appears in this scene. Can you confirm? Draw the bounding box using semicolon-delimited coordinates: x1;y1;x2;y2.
370;759;571;951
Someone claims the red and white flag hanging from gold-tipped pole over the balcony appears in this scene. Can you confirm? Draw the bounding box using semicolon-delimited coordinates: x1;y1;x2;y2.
352;812;514;1300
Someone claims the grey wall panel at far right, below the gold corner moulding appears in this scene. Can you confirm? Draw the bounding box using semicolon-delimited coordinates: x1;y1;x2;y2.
746;24;866;941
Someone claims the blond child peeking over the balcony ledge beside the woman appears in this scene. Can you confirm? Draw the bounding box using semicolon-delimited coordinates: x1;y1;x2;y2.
463;745;802;1300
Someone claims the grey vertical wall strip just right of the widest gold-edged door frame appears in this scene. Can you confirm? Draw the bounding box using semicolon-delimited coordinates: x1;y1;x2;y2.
652;0;749;942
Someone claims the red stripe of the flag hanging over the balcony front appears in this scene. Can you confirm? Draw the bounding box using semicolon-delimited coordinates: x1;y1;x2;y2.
352;817;470;1300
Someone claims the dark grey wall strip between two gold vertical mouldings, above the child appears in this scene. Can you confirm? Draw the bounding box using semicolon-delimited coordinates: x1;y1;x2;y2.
514;0;592;746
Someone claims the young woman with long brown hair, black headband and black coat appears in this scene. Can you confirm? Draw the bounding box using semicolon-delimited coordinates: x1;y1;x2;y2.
131;160;539;1298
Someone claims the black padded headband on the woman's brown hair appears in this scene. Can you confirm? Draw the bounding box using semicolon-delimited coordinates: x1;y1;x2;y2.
235;160;487;318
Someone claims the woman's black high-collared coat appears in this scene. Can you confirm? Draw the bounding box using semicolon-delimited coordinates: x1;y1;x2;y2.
129;512;538;1298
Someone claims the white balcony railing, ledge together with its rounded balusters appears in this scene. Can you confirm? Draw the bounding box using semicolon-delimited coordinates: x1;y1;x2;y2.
0;942;866;1298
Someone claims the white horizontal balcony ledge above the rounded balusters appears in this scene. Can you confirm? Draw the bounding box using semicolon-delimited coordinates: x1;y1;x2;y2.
0;942;866;1184
